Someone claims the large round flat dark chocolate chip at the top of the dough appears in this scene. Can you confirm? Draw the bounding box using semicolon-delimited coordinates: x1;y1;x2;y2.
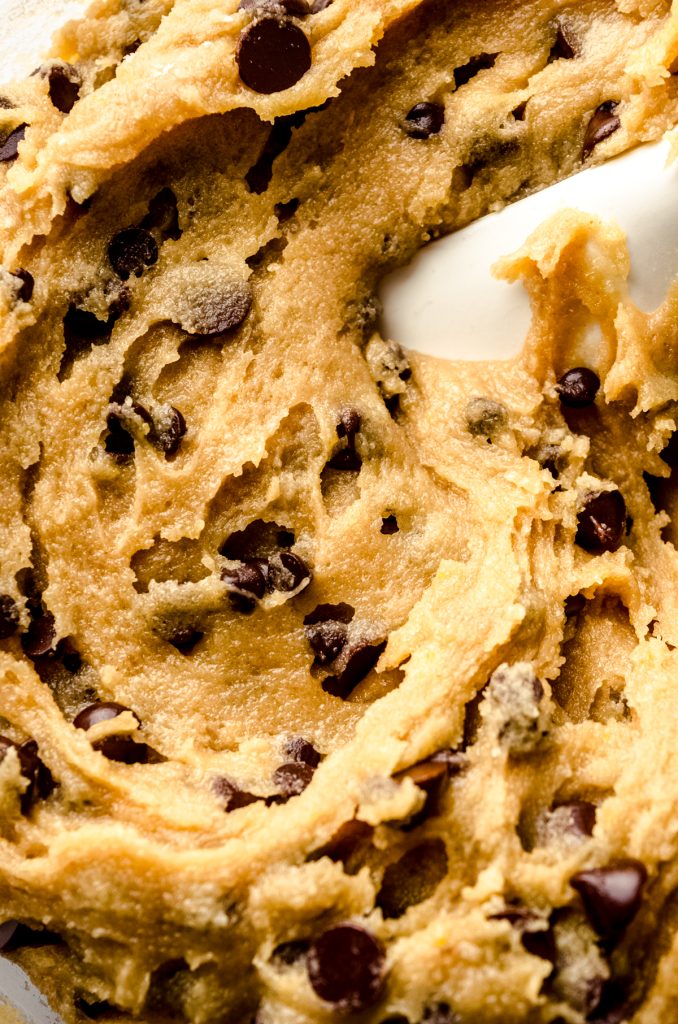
236;15;311;94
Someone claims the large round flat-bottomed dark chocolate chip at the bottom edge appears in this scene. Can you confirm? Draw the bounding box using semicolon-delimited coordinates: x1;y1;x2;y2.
306;923;385;1013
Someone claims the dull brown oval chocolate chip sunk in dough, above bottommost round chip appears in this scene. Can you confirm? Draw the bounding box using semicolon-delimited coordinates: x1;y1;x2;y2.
377;839;448;918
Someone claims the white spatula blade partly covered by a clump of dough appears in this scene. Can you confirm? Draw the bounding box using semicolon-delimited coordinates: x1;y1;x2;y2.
381;141;678;359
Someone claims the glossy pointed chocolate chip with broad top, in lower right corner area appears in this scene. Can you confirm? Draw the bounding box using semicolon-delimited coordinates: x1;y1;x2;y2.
569;860;647;939
